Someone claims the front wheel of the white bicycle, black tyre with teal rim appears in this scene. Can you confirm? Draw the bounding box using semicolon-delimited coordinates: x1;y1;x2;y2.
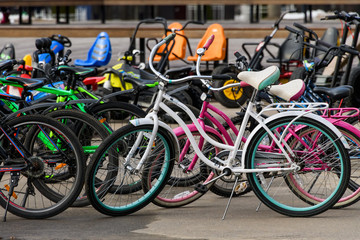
86;125;176;216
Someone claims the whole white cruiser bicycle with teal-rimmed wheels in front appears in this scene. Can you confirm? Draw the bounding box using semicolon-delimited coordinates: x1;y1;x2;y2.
86;34;350;217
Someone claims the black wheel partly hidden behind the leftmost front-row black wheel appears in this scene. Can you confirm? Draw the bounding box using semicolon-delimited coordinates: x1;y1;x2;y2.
47;109;110;207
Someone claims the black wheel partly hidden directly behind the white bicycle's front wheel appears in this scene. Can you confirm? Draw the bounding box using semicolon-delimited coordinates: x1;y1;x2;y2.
88;102;146;132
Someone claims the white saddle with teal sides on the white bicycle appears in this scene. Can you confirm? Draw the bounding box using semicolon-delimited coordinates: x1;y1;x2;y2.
237;66;280;90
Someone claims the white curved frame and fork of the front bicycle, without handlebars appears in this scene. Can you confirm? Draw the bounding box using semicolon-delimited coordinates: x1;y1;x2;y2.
130;84;341;174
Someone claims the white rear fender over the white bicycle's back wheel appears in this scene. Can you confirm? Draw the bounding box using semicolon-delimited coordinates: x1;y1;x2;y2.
244;111;350;156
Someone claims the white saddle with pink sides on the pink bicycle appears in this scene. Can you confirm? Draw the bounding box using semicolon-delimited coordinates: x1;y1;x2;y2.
269;79;305;102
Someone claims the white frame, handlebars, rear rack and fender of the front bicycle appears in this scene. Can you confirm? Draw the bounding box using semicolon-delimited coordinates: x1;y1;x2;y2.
127;36;348;175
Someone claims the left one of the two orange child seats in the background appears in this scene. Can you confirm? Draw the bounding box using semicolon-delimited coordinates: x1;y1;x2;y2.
154;22;186;62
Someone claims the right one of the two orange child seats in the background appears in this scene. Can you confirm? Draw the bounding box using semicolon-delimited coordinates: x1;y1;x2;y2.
187;23;226;62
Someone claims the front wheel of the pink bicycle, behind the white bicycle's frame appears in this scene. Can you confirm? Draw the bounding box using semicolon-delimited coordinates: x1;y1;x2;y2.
153;131;223;208
